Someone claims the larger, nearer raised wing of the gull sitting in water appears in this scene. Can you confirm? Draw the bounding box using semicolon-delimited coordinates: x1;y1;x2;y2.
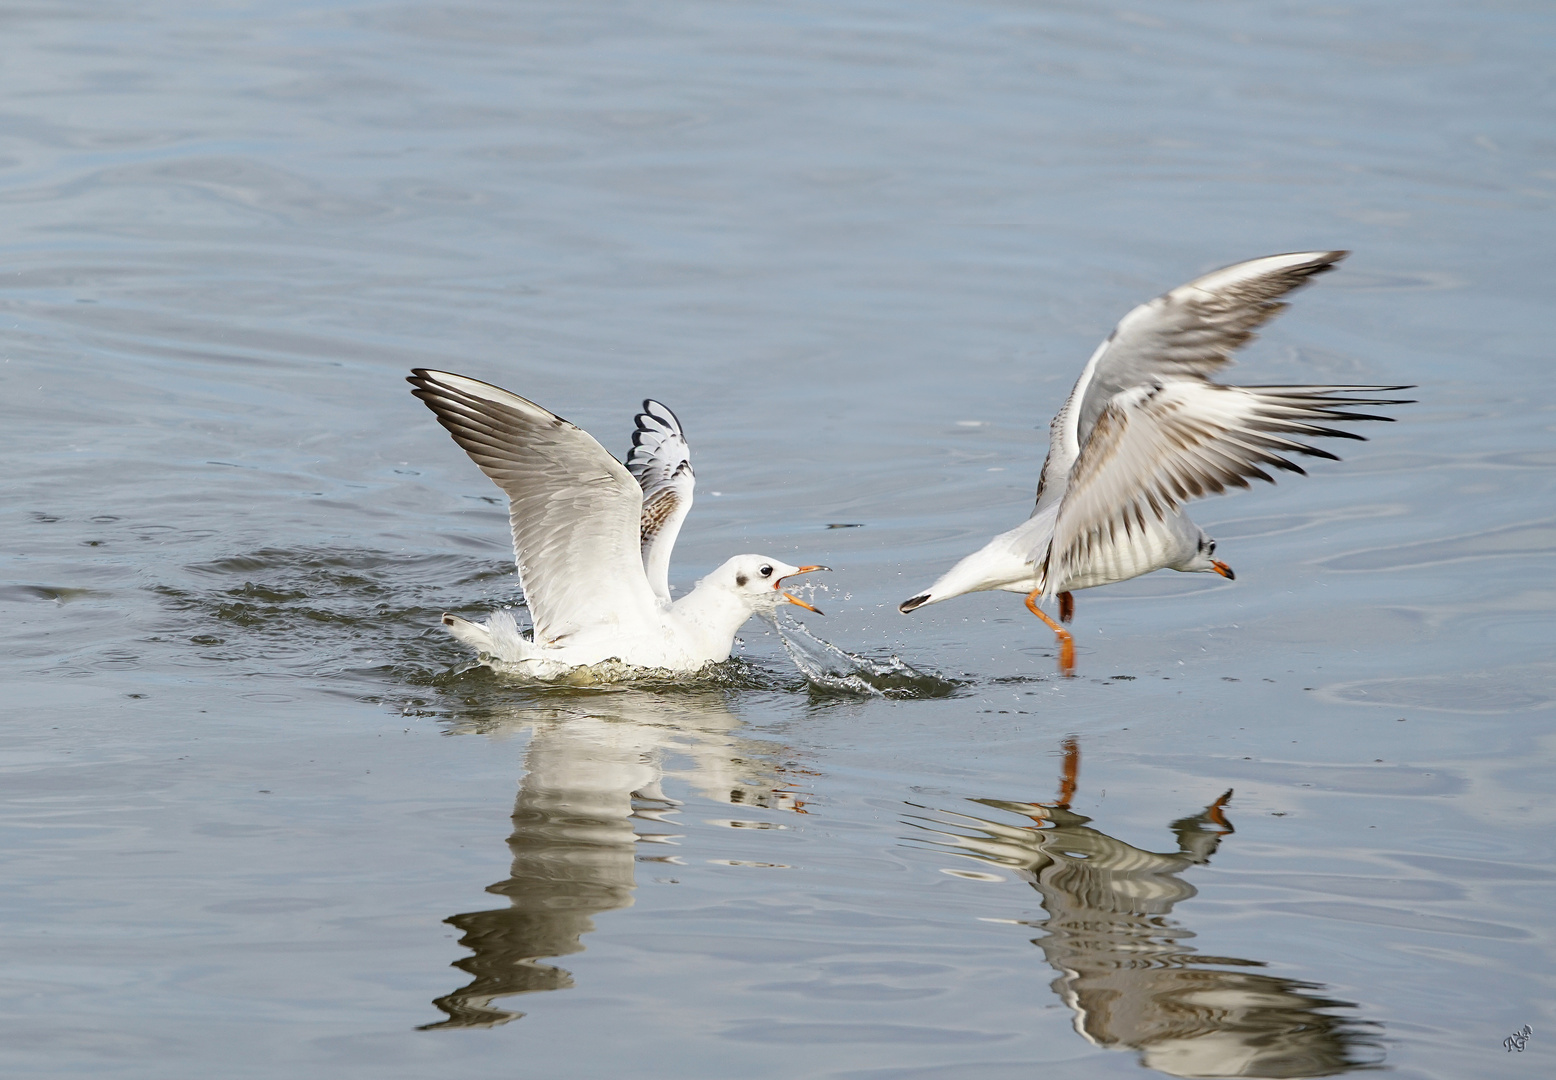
408;367;658;644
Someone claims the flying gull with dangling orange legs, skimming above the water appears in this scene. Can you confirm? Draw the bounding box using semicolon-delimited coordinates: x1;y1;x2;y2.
899;251;1410;675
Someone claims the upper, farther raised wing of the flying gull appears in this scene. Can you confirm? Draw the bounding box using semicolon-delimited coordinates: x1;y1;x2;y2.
1033;251;1349;514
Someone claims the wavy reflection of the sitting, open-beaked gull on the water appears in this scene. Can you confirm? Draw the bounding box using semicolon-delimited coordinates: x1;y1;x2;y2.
422;691;804;1030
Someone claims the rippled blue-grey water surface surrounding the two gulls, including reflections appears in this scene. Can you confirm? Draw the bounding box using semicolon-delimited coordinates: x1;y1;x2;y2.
0;0;1556;1080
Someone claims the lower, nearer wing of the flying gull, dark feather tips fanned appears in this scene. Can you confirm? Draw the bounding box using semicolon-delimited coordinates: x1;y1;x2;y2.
1039;382;1408;600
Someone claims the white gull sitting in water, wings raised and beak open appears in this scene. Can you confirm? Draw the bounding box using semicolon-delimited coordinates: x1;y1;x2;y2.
406;367;828;679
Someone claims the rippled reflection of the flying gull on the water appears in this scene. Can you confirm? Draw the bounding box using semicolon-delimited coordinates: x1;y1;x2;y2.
912;739;1382;1077
